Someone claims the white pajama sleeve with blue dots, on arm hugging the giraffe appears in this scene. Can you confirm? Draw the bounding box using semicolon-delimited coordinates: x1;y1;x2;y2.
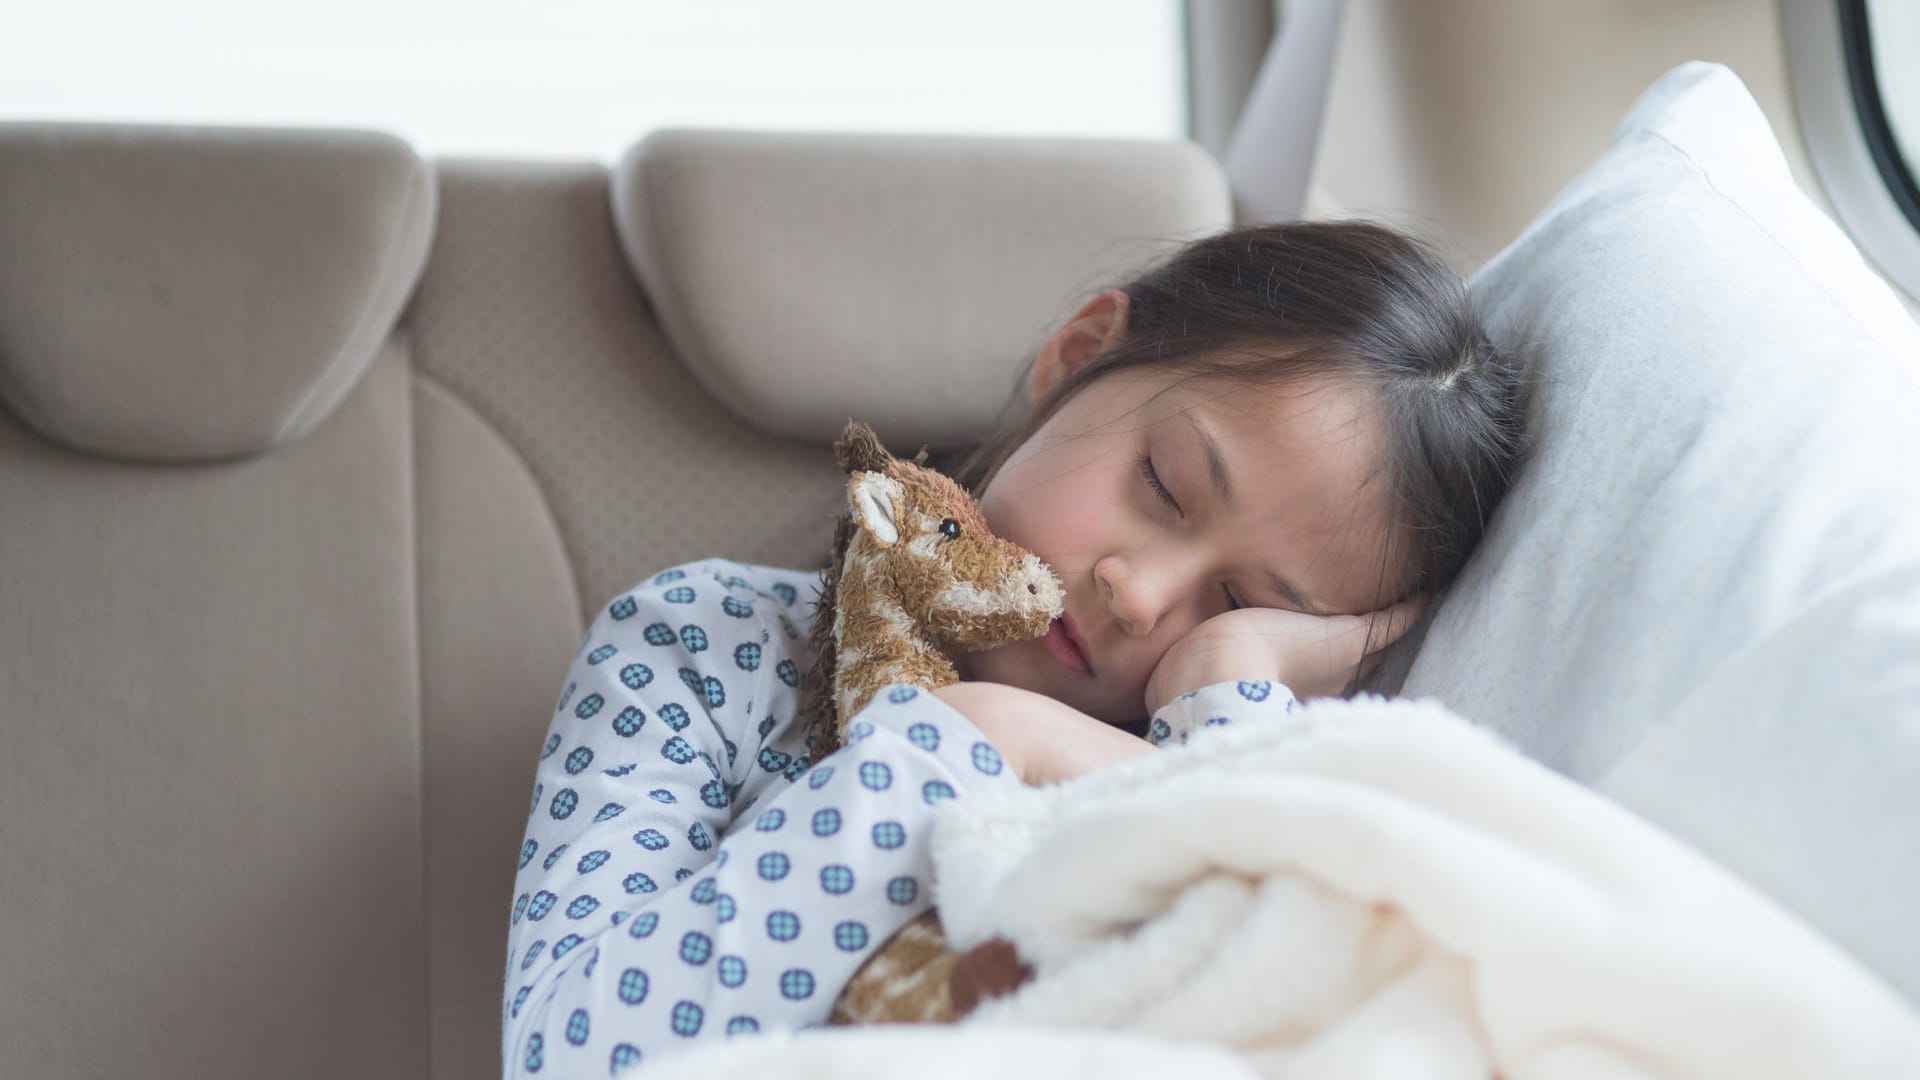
501;561;1018;1076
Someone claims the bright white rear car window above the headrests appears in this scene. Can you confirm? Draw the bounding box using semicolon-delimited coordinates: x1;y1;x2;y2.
0;0;1187;161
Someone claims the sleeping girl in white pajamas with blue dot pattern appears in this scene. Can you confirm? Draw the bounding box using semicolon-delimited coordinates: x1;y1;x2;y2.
501;223;1521;1076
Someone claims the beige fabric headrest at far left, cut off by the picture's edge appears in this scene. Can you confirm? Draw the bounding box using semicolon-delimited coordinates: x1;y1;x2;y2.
0;123;436;461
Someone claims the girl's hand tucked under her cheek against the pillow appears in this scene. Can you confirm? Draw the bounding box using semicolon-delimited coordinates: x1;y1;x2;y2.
1146;600;1423;715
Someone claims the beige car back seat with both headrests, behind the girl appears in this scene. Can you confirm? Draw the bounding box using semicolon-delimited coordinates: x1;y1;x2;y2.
0;125;1229;1078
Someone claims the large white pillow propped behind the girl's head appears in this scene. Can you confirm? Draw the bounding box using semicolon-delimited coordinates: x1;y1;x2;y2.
1402;63;1920;1001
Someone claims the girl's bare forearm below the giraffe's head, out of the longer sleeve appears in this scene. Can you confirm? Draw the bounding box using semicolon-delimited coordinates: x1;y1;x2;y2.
933;682;1154;786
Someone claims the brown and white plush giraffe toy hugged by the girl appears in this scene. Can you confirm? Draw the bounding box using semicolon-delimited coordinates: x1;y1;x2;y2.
801;421;1064;1024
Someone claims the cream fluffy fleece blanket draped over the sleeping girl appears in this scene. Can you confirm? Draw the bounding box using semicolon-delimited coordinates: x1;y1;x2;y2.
648;698;1920;1080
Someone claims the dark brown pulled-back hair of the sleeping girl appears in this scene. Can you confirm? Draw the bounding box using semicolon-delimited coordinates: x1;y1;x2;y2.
952;221;1524;618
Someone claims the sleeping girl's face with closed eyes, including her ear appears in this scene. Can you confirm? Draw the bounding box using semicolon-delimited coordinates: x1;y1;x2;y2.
956;292;1400;723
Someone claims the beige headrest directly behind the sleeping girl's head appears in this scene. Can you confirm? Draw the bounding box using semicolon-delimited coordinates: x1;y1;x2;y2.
612;131;1233;454
